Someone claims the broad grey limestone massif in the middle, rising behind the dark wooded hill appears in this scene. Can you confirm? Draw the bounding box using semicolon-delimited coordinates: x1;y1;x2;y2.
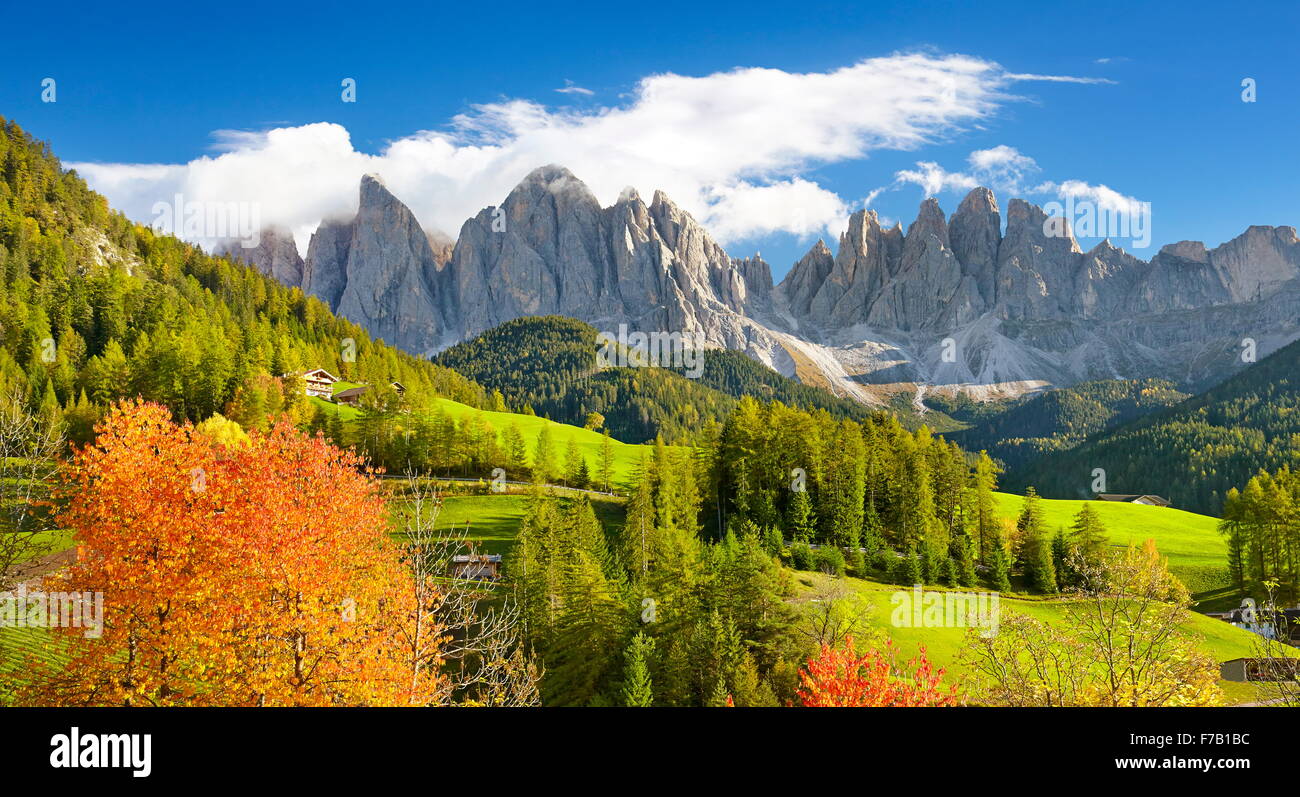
446;166;772;347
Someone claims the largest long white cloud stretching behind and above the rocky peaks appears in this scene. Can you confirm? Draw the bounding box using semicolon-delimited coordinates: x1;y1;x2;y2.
74;55;1107;248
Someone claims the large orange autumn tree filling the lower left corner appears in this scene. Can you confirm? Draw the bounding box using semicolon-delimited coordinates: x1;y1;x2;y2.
21;400;443;706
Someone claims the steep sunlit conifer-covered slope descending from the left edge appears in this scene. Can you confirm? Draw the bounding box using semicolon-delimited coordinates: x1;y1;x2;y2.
0;118;485;441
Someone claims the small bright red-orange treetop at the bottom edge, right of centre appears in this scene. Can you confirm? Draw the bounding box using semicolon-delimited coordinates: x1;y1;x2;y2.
796;637;957;707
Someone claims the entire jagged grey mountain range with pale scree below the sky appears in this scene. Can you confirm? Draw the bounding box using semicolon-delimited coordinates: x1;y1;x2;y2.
224;165;1300;403
